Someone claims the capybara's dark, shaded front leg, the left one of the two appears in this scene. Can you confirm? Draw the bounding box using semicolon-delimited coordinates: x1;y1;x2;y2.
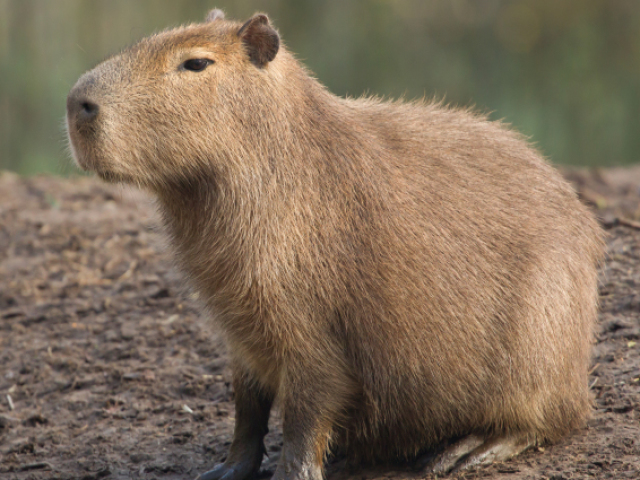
197;365;273;480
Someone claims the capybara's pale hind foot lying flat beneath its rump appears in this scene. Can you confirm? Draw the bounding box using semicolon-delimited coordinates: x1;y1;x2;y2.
426;434;535;473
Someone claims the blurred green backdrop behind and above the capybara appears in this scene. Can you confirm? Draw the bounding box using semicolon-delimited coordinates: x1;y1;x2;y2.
0;0;640;174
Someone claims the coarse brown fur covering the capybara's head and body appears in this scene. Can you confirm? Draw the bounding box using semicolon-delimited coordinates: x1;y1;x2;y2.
68;9;602;478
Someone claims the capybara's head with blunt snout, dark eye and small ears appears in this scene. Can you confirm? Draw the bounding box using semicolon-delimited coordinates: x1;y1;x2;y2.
67;10;283;189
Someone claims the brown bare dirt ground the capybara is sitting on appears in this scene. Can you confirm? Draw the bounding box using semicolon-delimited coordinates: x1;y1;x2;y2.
0;168;640;480
